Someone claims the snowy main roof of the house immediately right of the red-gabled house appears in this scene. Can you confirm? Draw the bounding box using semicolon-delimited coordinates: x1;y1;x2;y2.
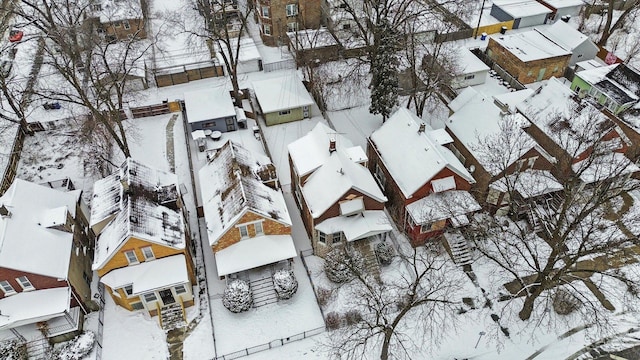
446;87;537;175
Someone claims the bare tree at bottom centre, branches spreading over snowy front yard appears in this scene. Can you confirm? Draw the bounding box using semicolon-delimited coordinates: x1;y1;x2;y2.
322;248;464;360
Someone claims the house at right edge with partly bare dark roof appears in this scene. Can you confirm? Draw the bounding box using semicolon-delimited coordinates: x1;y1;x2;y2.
571;64;640;115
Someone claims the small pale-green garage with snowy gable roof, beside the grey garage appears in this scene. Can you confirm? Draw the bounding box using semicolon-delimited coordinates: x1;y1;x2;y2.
252;75;315;126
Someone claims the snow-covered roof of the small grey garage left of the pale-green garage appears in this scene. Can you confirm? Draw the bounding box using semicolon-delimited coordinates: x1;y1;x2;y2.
184;85;236;124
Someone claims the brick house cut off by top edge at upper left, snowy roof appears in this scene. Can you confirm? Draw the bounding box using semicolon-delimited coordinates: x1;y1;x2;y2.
91;0;147;41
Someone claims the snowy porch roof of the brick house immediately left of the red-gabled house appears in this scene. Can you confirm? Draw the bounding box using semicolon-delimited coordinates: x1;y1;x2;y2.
316;210;393;241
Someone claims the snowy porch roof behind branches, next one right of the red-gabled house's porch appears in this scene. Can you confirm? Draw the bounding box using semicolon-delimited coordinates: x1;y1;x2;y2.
489;169;564;199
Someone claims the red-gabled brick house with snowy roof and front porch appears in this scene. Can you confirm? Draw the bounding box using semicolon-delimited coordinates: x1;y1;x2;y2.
367;108;480;246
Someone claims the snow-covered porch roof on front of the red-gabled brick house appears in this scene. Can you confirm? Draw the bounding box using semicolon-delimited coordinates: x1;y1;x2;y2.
406;190;480;224
